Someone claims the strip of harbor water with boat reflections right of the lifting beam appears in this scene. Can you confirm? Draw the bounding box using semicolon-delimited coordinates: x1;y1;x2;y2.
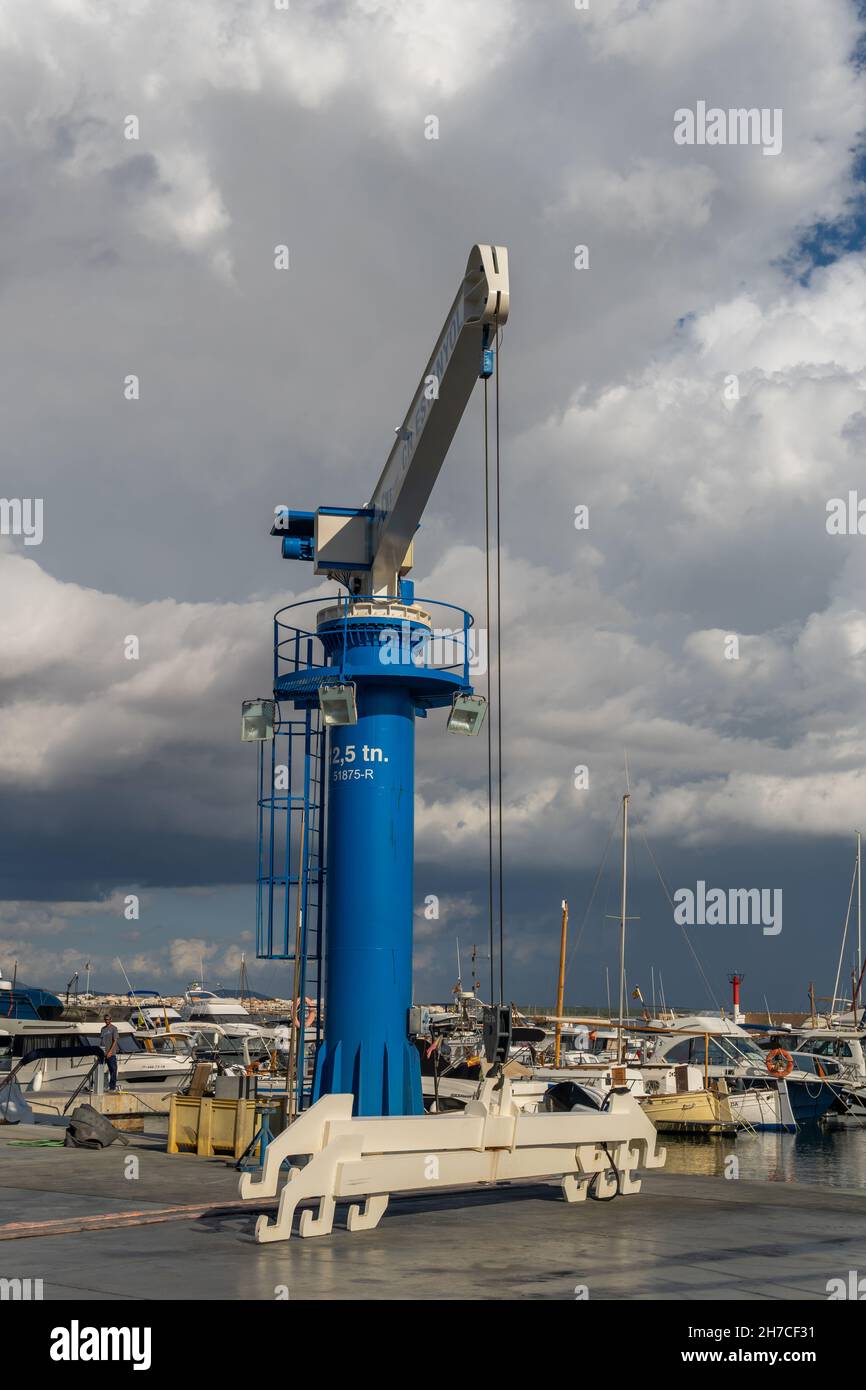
662;1126;866;1188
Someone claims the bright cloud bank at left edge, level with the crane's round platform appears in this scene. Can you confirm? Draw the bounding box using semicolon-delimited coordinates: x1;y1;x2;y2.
0;546;277;790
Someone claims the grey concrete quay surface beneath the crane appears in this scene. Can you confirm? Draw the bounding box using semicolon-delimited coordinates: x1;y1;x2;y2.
0;1126;866;1301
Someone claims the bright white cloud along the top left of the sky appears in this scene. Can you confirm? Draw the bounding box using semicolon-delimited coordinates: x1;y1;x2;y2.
0;0;520;281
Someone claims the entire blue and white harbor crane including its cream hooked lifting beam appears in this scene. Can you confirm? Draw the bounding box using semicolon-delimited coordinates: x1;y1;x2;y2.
239;246;664;1243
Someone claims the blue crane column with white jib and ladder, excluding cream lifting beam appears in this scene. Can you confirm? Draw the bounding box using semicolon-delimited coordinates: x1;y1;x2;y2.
246;246;509;1115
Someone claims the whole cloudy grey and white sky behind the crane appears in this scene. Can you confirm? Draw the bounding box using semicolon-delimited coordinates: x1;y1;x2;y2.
0;0;866;1008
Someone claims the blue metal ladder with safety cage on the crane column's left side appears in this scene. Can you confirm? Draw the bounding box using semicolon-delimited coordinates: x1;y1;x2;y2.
256;705;325;1108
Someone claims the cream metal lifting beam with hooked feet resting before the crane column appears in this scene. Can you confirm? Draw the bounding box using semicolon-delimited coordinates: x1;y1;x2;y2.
240;1079;664;1243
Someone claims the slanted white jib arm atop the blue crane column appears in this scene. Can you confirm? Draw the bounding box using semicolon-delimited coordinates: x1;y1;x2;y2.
367;246;509;594
